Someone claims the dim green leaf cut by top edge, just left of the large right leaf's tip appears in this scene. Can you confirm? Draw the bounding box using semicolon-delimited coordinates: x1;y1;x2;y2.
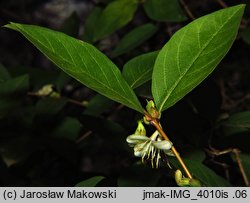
144;0;187;22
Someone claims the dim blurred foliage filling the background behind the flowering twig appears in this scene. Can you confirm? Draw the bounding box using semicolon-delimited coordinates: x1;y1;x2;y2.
0;0;250;186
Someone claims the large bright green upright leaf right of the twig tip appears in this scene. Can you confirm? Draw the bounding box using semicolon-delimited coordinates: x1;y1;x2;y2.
152;5;245;111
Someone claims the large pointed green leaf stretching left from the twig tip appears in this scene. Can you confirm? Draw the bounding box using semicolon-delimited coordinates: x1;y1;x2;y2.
5;23;143;112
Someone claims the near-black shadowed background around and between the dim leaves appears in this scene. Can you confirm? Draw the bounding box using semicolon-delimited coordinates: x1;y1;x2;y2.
0;0;250;186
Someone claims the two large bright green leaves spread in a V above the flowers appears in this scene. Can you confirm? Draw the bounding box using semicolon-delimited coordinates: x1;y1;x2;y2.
5;5;245;113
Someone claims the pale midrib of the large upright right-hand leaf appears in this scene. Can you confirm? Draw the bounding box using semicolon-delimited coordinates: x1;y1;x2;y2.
159;9;239;112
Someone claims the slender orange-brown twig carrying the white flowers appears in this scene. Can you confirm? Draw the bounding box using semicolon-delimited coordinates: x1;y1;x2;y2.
145;112;193;179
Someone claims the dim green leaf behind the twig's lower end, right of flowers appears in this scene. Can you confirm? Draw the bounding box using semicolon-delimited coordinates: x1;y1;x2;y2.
170;151;230;187
